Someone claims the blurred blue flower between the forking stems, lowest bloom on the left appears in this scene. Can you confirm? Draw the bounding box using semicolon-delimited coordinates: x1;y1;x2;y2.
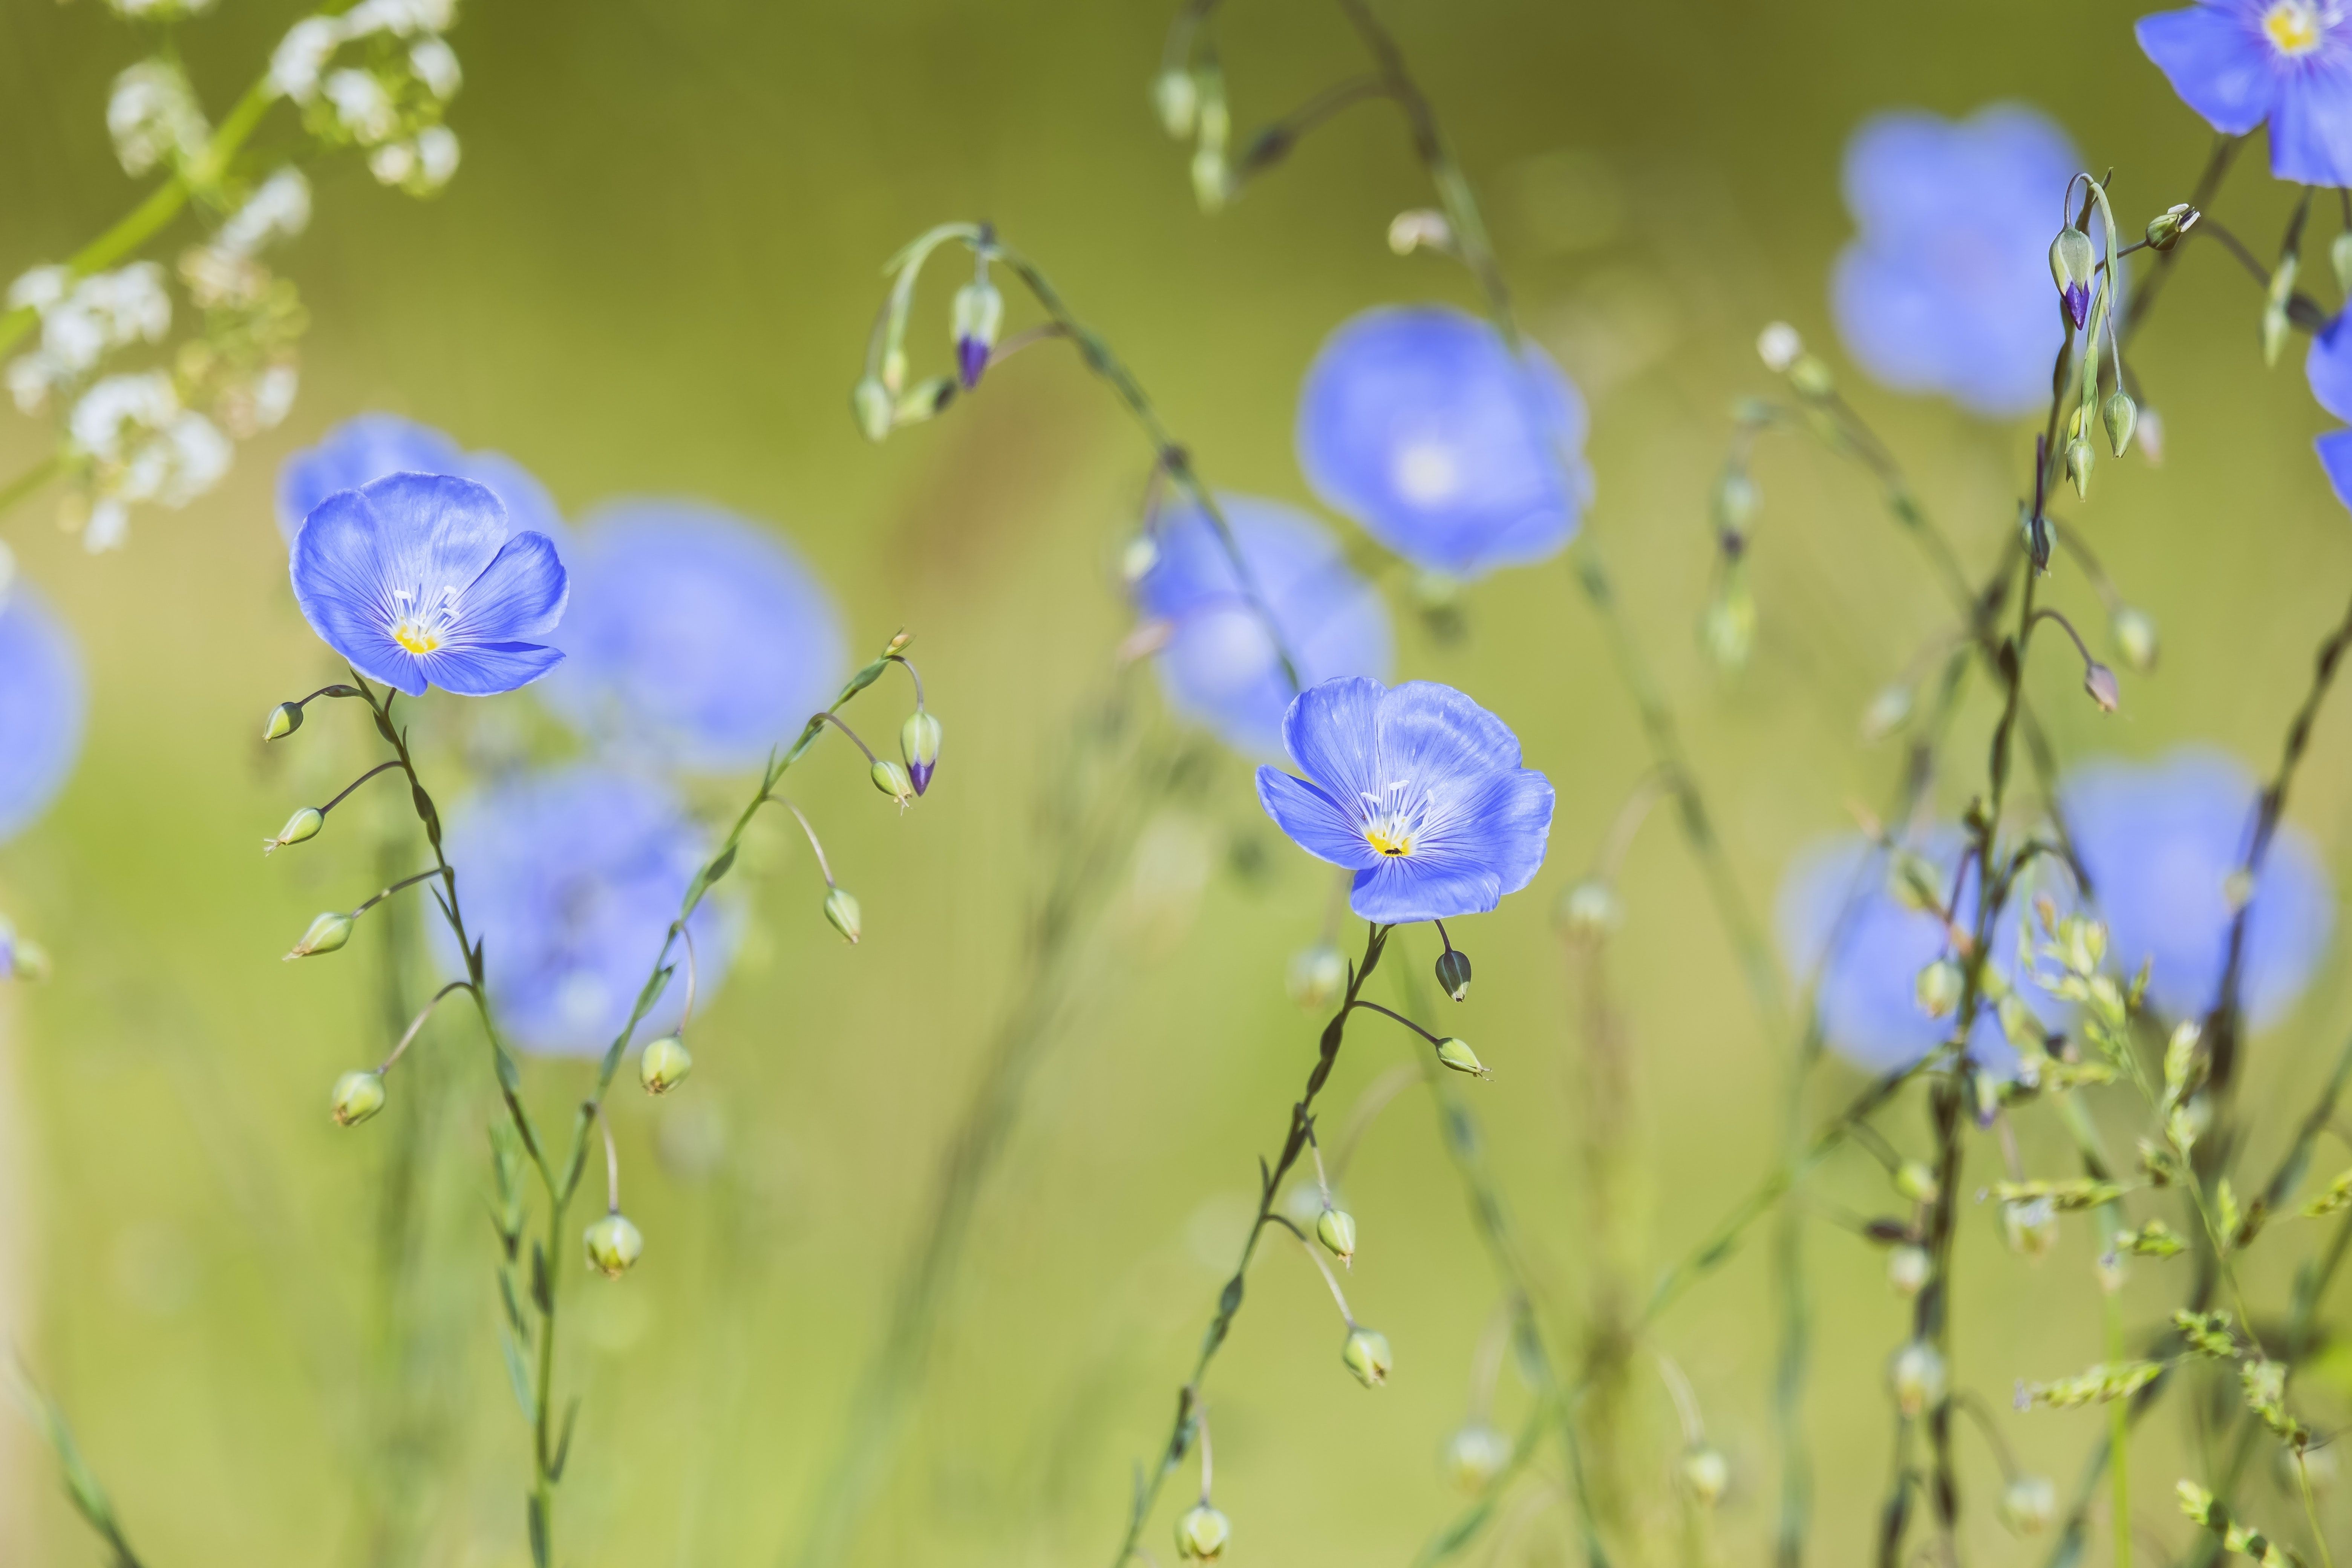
435;764;734;1055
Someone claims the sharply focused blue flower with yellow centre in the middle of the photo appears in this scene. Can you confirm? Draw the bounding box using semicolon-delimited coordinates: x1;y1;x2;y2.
1258;675;1552;926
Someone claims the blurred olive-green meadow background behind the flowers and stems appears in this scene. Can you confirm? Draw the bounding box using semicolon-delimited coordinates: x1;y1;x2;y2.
0;0;2352;1568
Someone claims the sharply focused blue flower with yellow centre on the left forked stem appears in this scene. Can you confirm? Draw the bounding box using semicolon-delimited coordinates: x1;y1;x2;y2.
292;473;567;696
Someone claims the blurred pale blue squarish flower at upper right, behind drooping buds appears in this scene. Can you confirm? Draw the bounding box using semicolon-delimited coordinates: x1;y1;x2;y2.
1830;103;2105;418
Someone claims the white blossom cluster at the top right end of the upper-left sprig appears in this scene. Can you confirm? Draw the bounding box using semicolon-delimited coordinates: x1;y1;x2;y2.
268;0;463;195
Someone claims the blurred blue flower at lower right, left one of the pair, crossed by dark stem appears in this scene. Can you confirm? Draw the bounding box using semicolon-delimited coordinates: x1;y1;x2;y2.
1773;830;2063;1076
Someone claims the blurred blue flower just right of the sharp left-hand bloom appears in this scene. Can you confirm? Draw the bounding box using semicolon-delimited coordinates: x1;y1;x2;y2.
541;501;849;771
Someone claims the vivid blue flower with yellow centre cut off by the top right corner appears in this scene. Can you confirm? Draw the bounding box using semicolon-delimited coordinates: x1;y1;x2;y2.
2136;0;2352;186
